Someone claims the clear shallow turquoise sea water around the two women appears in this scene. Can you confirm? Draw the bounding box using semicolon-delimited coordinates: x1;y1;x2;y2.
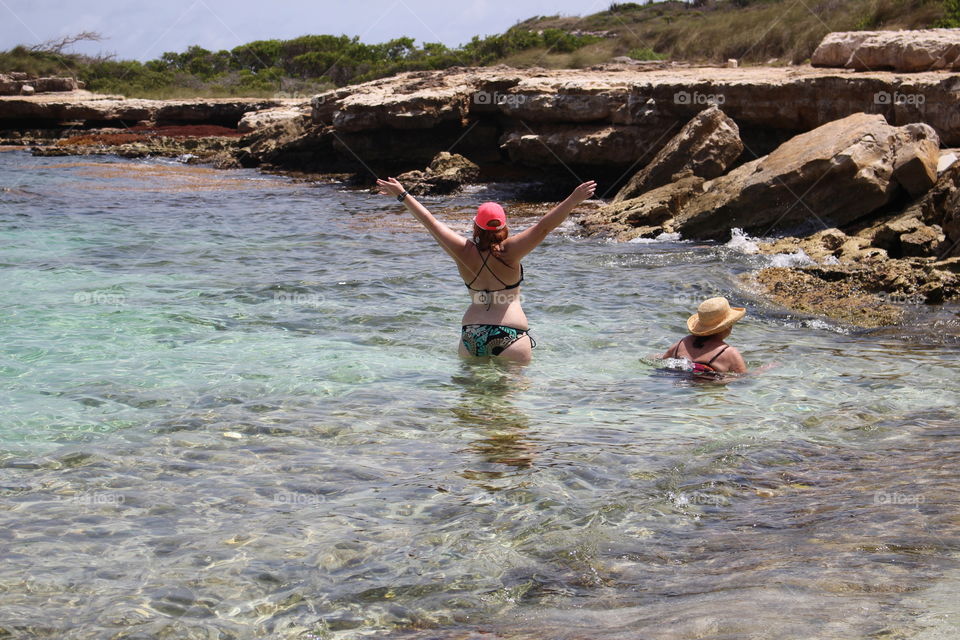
0;152;960;639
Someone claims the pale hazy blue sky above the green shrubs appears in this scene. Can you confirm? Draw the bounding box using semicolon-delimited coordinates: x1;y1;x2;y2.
0;0;610;60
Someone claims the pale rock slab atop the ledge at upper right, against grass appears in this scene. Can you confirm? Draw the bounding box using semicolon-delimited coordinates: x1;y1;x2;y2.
810;29;960;72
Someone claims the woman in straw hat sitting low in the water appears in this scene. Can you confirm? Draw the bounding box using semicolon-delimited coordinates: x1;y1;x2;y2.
660;298;747;376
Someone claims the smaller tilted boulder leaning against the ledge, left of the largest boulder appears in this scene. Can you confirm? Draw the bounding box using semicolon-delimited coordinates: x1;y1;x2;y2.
613;105;743;202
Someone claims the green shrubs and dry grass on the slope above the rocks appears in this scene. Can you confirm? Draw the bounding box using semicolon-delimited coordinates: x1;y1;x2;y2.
0;0;948;98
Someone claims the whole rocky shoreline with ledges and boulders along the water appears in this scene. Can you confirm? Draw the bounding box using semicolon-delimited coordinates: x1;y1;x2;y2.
0;30;960;327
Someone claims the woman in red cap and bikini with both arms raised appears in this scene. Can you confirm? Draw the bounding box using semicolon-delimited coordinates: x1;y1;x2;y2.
377;178;597;362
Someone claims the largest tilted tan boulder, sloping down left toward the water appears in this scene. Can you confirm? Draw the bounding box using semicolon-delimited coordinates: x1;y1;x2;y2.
674;113;936;239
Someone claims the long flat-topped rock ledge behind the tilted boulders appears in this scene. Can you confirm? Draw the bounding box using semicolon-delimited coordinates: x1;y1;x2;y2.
231;64;960;180
